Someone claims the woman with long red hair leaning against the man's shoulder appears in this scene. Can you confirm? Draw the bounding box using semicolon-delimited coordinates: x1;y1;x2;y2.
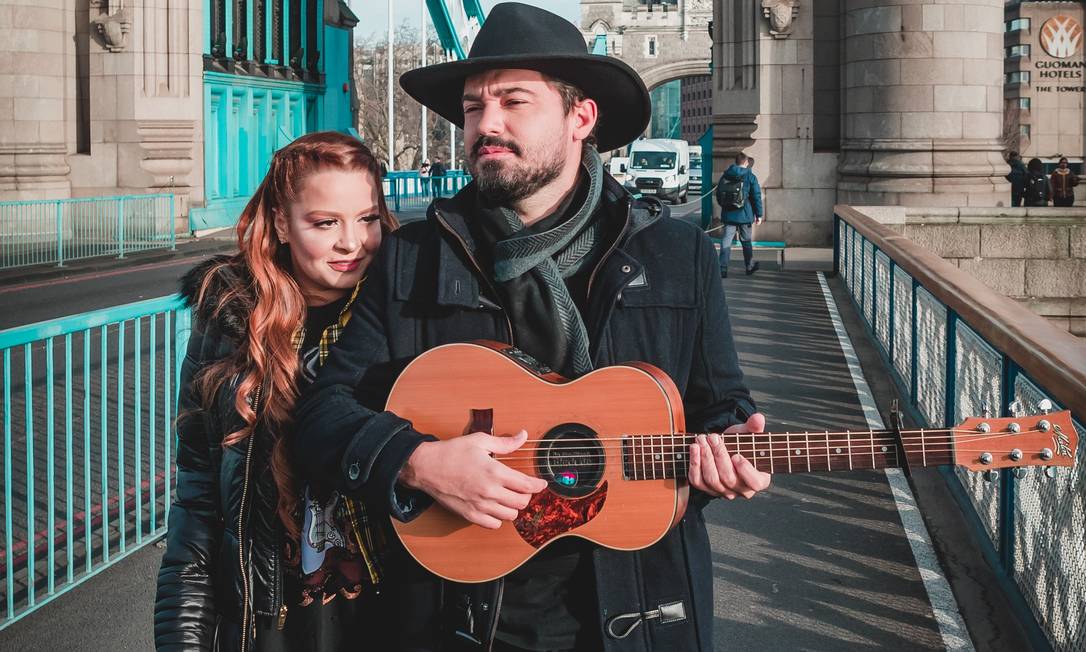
154;131;396;652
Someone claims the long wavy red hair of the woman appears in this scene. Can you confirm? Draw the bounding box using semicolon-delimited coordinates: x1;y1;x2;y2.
198;131;399;536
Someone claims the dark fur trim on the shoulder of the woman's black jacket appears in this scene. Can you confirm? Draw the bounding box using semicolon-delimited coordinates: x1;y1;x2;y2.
180;254;255;342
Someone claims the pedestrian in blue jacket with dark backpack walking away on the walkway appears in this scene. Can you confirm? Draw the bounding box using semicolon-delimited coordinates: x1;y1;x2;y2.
717;152;765;278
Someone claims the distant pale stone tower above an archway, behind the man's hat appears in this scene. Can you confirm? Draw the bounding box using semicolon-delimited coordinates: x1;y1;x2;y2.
581;0;712;95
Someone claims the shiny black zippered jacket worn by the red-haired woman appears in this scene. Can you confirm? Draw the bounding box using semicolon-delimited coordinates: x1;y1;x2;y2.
154;259;283;651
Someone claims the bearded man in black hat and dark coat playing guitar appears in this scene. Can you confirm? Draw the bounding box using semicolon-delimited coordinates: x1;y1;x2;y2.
293;2;770;651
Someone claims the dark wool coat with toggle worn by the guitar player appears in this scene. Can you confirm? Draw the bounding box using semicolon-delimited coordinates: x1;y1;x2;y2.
293;177;755;652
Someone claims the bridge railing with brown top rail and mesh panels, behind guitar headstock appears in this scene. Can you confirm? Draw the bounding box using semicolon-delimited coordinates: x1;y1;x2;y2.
834;205;1086;652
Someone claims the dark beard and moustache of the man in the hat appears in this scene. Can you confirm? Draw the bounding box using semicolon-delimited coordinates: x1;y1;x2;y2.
470;136;565;206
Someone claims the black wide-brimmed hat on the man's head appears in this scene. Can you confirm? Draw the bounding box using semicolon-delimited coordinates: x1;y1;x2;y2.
400;2;652;151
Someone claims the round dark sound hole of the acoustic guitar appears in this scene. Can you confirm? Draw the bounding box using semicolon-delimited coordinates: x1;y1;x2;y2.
535;424;605;498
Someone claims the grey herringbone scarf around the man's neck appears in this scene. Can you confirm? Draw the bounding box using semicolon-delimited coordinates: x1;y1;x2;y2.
494;147;604;376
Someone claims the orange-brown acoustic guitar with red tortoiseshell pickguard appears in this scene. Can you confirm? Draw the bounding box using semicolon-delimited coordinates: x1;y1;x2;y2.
387;342;1077;582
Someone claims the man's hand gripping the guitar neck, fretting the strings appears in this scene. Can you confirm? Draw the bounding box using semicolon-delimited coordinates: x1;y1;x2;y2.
689;412;771;500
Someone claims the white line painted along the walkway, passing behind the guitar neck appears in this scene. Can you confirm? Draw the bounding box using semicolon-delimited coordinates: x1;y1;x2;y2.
818;272;974;652
